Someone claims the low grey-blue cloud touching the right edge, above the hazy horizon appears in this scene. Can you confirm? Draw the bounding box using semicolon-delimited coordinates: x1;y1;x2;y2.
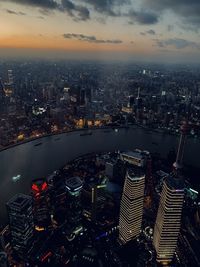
154;38;200;49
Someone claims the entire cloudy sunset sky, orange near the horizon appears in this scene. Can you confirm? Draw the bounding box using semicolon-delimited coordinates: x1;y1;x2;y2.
0;0;200;63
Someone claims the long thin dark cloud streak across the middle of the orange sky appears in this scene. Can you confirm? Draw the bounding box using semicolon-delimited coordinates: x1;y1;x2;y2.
63;33;122;44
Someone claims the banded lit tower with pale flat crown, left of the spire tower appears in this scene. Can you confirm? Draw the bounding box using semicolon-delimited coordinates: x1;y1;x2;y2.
119;169;145;244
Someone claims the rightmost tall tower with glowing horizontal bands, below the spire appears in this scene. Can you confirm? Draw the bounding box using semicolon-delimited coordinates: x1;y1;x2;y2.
153;176;184;264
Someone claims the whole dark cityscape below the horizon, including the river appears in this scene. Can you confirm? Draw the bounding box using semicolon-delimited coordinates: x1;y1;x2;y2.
0;56;200;267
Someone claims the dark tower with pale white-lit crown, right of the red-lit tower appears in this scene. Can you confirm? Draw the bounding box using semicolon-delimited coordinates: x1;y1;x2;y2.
65;177;83;233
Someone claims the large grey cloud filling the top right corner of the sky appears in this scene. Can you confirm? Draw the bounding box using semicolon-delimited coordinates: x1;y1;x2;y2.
143;0;200;27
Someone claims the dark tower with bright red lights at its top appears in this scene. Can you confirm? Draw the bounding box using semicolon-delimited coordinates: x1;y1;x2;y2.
31;178;50;231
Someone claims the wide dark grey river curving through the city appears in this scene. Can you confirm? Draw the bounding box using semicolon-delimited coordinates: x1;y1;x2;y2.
0;127;200;224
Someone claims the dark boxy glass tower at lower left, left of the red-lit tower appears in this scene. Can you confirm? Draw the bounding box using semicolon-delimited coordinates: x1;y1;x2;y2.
7;194;34;258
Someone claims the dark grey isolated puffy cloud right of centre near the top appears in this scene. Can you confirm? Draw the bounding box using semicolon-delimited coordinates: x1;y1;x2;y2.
128;9;159;25
